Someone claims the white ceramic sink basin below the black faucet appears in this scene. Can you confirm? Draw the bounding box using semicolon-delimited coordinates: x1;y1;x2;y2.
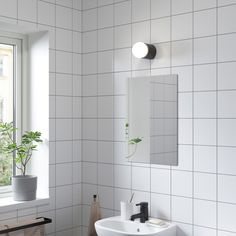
95;216;176;236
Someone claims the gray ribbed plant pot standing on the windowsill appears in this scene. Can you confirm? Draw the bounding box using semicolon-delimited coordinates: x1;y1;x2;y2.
12;175;37;201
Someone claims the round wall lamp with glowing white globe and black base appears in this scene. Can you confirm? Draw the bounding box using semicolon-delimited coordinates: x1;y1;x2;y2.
132;42;156;59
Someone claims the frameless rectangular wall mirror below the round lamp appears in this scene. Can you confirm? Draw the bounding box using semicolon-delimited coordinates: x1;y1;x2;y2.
126;75;178;165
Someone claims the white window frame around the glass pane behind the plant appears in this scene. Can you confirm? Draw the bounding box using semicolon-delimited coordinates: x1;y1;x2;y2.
0;31;26;198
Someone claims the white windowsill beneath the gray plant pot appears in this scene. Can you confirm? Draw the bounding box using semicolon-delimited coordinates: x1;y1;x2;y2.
0;197;49;213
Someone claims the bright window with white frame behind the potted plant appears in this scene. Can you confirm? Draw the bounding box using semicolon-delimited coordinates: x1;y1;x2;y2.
0;37;21;192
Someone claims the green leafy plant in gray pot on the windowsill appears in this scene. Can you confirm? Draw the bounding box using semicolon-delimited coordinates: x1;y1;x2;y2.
0;123;42;201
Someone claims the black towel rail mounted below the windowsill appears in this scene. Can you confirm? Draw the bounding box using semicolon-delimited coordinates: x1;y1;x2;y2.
0;217;52;234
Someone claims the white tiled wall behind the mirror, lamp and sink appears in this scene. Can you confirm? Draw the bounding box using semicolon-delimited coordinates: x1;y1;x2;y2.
81;0;236;236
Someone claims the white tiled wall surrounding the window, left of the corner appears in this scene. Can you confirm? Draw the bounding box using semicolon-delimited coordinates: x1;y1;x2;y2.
0;0;82;236
